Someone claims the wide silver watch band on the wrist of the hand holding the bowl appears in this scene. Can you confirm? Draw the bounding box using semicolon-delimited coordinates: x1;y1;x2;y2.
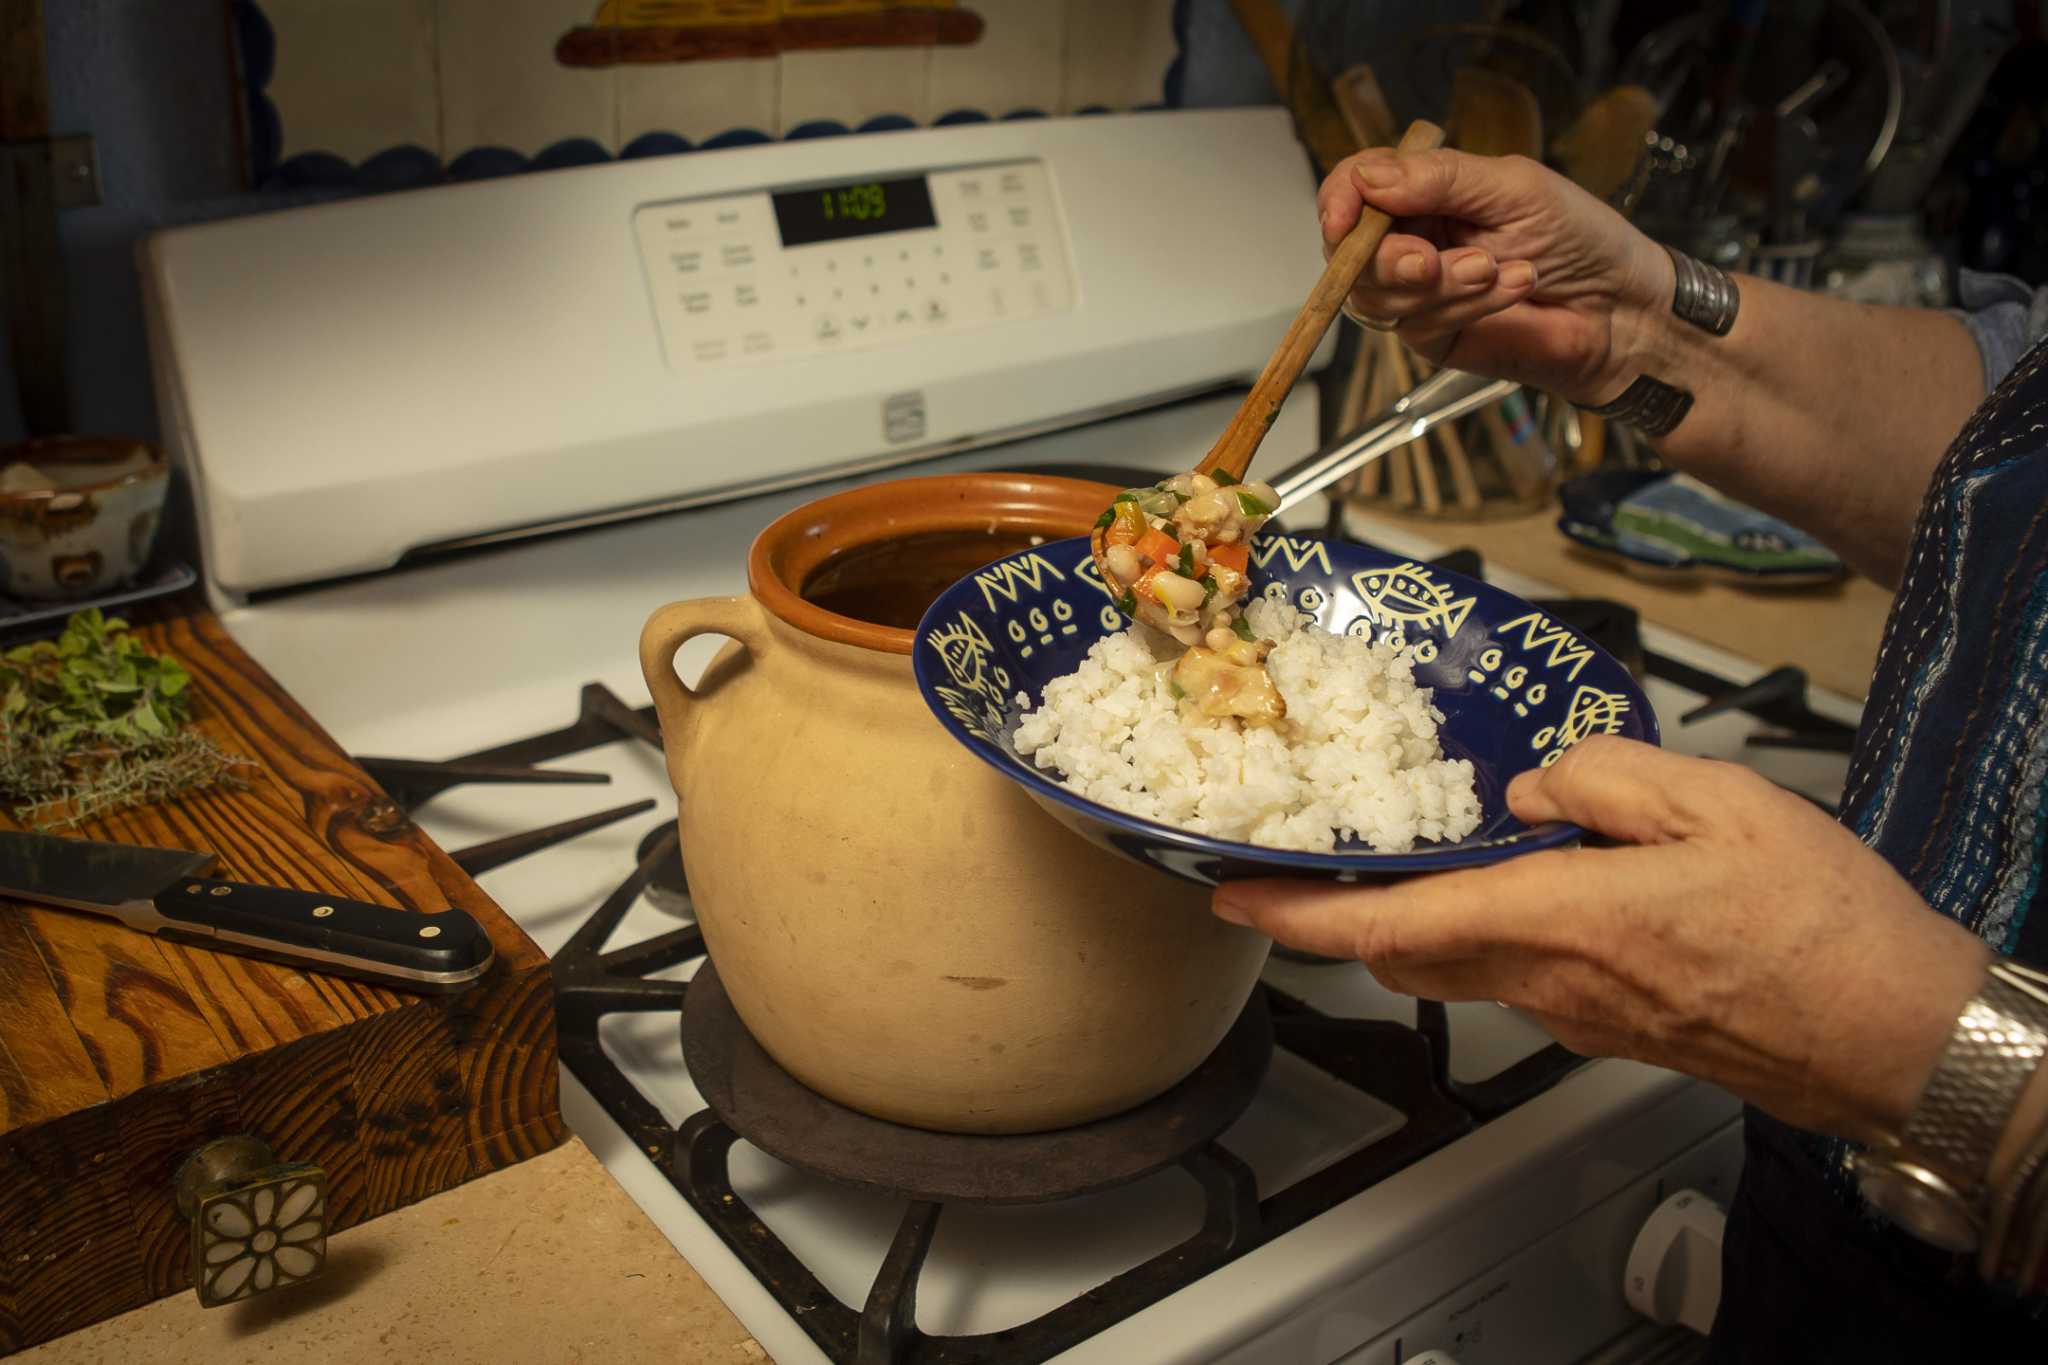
1898;960;2048;1189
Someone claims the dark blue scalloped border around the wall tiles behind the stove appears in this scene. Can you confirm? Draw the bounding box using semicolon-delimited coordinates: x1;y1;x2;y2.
231;0;1190;194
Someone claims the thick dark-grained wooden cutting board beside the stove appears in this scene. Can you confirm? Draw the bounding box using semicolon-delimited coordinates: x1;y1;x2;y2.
0;600;563;1355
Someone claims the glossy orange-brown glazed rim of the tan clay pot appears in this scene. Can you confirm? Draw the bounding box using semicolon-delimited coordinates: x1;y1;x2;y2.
748;473;1116;655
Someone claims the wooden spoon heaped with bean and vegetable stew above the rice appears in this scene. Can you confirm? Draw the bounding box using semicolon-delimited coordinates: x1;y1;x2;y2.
1090;119;1444;649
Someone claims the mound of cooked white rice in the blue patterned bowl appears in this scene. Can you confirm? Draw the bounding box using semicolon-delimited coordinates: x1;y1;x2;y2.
1016;600;1479;853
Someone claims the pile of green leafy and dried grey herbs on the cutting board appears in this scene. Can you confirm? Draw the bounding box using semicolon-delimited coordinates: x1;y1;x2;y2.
0;608;242;829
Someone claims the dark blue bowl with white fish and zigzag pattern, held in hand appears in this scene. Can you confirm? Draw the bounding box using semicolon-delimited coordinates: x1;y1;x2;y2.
911;534;1657;884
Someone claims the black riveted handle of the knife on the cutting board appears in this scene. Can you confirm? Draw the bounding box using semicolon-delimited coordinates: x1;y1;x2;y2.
154;876;494;993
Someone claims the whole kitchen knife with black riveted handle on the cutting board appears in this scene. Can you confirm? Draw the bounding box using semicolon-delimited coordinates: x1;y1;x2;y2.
0;831;496;993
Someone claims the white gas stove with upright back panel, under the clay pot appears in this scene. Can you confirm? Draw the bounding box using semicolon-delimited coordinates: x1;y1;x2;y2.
147;111;1855;1365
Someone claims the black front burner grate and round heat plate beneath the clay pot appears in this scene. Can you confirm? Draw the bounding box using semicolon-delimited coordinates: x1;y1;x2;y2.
555;827;1490;1365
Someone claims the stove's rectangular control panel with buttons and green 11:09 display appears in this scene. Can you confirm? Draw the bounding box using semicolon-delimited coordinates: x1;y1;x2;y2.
633;160;1075;372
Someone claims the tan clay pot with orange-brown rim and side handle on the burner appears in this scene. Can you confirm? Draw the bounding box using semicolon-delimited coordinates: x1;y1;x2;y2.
641;475;1270;1134
